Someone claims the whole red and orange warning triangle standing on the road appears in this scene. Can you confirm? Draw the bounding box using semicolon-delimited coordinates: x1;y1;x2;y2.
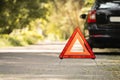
59;27;95;59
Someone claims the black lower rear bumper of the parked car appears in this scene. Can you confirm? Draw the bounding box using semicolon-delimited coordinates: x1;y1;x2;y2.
89;35;120;48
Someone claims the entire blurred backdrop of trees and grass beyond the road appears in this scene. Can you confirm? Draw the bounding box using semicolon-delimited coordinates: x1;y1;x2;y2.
0;0;94;47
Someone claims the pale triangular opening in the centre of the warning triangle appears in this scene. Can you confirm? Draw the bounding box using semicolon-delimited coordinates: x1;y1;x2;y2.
70;39;84;52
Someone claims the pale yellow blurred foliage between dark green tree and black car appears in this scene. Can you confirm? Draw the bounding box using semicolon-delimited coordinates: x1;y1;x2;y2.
46;0;84;40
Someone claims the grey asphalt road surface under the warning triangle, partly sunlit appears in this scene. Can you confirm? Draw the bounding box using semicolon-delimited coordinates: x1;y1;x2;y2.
0;43;120;80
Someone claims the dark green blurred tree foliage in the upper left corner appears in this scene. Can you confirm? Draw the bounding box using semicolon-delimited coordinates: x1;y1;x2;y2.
0;0;49;34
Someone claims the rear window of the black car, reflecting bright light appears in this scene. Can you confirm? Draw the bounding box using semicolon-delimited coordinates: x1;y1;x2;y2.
99;1;120;9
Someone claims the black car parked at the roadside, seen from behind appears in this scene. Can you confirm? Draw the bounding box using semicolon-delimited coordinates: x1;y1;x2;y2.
81;0;120;48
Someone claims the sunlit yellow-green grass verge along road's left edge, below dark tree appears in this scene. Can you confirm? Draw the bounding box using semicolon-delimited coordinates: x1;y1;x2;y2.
0;31;43;47
